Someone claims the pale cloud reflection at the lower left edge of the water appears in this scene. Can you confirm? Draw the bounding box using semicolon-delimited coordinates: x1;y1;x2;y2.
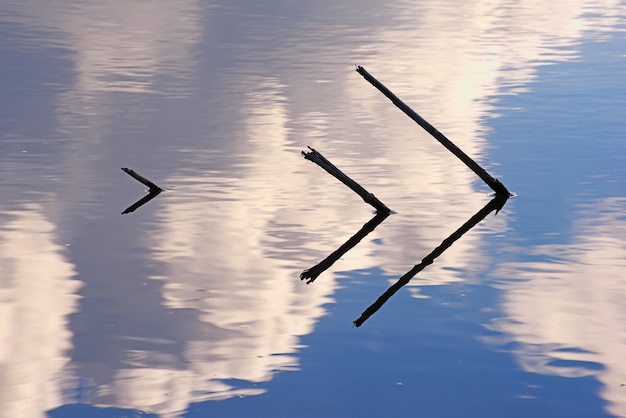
0;204;80;418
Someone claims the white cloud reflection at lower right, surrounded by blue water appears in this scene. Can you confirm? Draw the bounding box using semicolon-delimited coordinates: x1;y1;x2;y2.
490;198;626;416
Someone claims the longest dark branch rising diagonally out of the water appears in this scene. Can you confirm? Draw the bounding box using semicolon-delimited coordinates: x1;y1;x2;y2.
356;66;510;196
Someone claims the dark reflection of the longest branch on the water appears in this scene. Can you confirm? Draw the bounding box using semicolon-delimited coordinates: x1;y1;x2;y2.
354;193;509;327
